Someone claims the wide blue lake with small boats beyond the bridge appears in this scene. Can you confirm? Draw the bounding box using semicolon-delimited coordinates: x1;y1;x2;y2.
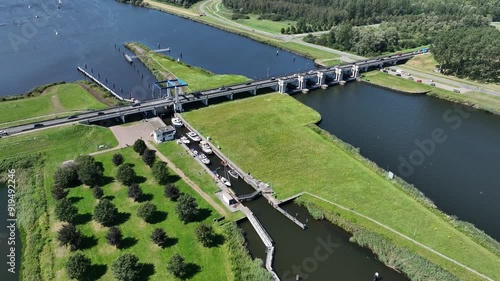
0;0;314;100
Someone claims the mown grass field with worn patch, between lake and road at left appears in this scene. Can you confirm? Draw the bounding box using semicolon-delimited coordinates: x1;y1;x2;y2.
0;84;107;127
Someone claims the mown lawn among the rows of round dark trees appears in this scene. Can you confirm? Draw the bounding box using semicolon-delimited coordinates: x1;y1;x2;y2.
49;148;231;281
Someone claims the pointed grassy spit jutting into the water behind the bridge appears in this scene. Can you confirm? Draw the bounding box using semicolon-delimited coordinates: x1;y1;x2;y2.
125;43;250;92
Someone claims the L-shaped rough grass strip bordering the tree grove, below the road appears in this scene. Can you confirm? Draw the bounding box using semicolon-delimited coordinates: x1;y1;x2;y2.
0;125;117;280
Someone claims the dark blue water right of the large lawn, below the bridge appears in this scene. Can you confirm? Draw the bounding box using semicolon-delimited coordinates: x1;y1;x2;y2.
295;83;500;240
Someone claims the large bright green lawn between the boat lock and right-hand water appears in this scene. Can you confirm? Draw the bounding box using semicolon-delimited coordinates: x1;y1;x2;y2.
183;94;500;280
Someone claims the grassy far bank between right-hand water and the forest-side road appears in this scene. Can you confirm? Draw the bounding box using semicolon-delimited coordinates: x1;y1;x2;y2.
363;71;500;114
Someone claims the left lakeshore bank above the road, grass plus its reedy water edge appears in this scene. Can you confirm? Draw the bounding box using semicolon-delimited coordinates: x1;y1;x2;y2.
0;81;118;128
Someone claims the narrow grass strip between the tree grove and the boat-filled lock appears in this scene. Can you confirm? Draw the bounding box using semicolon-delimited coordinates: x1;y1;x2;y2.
156;141;243;221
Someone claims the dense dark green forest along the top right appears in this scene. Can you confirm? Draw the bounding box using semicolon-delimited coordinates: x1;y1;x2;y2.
223;0;500;82
